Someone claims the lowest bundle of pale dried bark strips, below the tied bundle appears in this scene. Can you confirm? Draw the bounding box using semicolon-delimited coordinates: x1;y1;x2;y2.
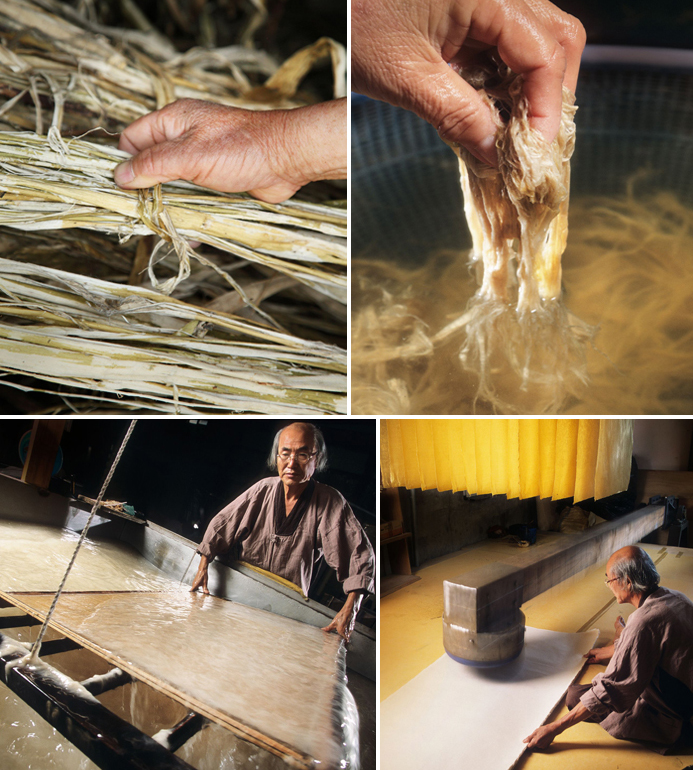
0;259;346;414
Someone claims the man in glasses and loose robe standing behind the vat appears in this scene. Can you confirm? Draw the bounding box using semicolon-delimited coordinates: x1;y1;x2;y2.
191;422;375;640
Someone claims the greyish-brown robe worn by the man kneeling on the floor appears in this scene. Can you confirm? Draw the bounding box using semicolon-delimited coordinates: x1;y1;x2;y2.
580;588;693;745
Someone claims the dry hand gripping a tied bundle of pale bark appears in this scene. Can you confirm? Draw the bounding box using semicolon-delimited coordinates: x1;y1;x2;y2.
114;99;347;203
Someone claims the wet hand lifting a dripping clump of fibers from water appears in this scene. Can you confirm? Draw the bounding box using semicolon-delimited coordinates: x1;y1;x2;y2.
351;0;585;165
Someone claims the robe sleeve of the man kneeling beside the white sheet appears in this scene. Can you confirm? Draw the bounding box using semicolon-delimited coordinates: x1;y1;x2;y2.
580;616;661;720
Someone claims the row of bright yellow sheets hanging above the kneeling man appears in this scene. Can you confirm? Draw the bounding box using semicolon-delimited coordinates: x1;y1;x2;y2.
380;419;633;502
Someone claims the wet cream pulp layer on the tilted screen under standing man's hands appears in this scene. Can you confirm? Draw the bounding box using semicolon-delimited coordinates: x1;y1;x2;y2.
0;522;343;765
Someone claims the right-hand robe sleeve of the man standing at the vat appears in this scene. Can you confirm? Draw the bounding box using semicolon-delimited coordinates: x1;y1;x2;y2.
318;490;375;593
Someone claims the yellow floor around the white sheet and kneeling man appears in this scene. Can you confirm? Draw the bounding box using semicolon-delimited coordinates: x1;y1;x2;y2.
380;533;693;770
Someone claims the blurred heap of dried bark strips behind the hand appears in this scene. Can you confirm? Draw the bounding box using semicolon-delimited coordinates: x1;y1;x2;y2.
0;0;346;136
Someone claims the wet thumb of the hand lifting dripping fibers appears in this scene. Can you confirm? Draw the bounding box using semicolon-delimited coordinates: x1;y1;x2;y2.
403;59;498;166
